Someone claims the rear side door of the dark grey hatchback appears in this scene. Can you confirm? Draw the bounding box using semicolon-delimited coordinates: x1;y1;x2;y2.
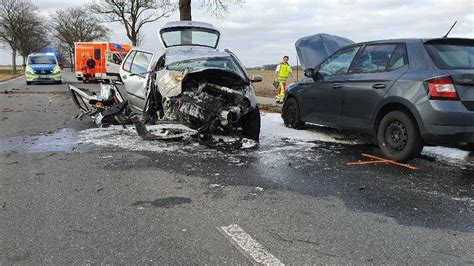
340;43;408;128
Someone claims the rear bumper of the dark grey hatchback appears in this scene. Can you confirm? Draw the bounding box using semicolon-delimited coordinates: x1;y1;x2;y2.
419;100;474;144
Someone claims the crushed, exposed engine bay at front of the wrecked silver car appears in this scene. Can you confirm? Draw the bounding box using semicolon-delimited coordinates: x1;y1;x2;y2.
156;69;251;137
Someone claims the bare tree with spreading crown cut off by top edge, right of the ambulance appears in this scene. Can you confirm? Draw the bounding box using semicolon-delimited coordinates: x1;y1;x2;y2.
90;0;176;46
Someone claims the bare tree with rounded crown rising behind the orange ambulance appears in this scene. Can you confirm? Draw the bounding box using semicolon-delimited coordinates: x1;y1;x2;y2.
52;7;109;71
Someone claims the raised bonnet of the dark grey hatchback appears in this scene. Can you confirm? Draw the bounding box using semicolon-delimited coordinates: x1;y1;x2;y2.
295;33;354;69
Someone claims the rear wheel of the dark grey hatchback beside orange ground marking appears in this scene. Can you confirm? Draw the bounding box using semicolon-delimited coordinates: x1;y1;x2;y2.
377;111;423;162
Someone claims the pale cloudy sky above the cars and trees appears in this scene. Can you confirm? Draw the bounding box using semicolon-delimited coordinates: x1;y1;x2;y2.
0;0;474;66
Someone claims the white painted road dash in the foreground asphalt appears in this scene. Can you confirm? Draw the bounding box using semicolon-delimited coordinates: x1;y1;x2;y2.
218;224;284;265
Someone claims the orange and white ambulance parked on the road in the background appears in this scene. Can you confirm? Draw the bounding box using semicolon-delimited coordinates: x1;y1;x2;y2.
74;42;132;82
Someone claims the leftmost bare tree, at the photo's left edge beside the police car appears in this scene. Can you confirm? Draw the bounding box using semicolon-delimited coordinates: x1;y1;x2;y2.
0;0;37;74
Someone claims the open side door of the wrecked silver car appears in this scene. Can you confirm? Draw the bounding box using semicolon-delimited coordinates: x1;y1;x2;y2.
120;50;153;111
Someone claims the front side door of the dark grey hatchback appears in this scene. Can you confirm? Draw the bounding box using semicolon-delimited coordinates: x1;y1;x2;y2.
301;46;360;124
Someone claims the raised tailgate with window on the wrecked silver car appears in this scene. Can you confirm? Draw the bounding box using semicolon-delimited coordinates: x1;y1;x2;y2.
158;21;220;49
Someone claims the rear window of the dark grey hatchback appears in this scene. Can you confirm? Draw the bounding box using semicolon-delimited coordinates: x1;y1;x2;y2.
425;42;474;69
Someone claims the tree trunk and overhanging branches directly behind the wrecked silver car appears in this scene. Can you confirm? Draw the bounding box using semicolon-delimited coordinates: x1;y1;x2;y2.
179;0;245;20
